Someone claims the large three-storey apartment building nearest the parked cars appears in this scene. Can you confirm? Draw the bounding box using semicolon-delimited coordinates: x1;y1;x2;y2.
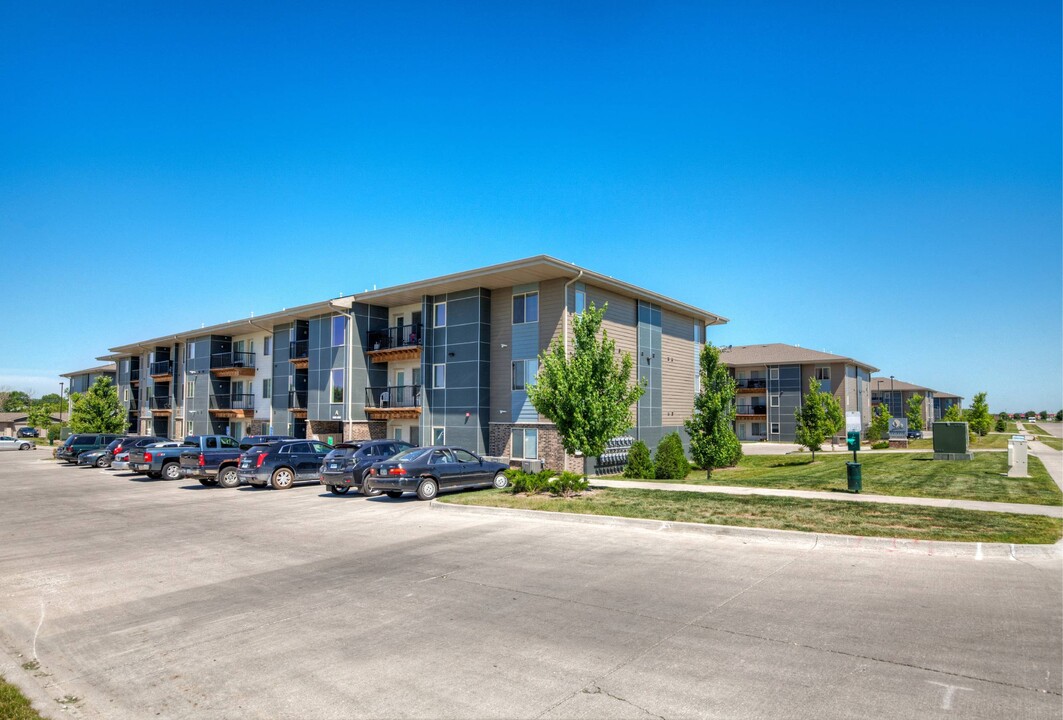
93;255;727;469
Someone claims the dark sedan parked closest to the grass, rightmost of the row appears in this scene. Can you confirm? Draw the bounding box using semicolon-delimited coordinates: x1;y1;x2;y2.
365;445;509;500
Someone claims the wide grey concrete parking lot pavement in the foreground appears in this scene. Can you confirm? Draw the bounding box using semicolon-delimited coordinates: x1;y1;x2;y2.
0;450;1063;718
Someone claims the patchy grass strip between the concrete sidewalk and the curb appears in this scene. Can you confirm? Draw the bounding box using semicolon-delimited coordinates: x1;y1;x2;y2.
439;488;1063;545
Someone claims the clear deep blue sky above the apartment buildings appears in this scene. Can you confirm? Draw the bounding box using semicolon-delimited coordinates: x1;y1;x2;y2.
0;0;1063;411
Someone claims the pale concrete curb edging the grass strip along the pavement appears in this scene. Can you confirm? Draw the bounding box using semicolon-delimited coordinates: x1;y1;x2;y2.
428;500;1063;560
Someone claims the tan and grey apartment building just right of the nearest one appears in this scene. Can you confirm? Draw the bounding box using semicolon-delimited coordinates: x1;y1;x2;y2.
720;342;878;442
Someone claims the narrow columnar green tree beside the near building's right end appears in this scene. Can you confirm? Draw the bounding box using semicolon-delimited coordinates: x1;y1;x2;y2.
684;342;742;478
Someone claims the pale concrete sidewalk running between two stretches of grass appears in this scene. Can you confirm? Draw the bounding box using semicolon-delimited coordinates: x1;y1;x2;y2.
590;476;1063;518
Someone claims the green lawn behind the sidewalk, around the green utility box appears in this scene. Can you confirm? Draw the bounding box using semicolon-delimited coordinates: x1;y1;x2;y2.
620;452;1063;505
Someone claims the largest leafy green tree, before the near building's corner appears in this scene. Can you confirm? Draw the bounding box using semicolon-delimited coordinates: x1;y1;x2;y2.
527;303;645;457
